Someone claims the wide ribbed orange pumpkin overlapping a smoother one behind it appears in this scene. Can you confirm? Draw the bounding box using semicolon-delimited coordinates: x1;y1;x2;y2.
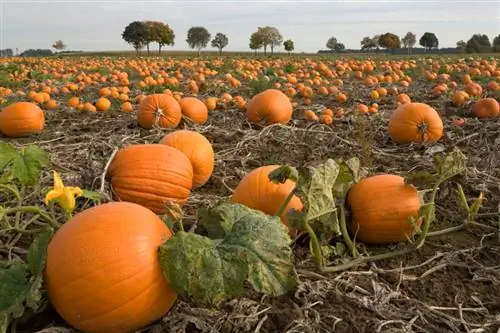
108;144;193;214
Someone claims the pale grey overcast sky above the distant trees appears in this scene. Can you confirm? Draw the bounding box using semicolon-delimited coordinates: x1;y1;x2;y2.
0;0;500;52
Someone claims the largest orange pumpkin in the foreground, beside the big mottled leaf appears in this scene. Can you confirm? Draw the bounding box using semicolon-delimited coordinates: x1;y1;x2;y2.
45;202;176;333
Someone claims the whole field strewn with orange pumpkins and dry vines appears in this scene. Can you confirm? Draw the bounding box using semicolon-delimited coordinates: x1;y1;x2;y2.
0;55;500;333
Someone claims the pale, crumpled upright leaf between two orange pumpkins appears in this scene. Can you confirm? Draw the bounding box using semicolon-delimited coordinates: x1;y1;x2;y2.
287;159;341;243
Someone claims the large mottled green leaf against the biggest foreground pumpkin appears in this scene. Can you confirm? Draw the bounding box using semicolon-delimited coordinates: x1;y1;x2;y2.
160;203;296;304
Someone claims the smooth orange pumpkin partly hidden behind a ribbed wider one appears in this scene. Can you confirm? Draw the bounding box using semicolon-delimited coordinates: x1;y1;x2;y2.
160;130;215;187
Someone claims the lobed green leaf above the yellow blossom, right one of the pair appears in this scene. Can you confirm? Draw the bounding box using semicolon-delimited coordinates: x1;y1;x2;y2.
12;145;50;185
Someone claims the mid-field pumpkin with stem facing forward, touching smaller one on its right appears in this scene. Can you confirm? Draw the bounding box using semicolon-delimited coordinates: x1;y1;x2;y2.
137;94;182;129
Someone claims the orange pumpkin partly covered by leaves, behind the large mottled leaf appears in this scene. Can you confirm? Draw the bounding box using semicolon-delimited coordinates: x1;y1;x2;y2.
231;165;304;225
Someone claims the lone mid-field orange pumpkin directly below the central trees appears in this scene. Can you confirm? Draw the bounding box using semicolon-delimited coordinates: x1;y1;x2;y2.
246;89;293;124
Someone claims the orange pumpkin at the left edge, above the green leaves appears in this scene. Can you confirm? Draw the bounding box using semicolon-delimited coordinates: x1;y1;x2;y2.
0;102;45;138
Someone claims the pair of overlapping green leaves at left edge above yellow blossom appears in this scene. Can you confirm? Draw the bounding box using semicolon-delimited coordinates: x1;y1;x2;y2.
0;143;50;185
